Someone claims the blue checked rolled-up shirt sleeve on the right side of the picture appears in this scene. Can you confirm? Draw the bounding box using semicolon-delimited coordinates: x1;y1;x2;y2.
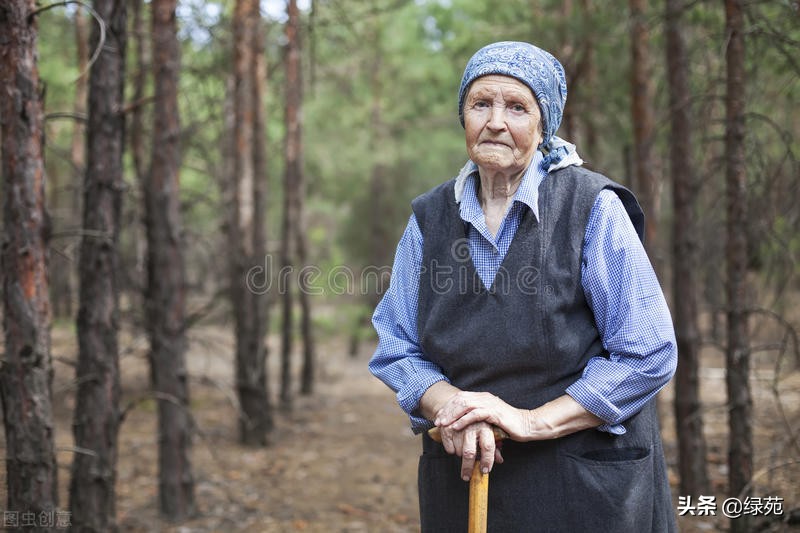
566;190;677;434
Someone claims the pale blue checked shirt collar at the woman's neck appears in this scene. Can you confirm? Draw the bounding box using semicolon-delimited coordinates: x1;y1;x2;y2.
455;150;547;222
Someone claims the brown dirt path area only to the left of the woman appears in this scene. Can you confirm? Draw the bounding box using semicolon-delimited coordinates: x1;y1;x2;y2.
49;327;419;533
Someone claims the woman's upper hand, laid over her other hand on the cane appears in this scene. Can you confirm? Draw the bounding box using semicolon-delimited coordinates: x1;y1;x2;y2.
434;391;532;441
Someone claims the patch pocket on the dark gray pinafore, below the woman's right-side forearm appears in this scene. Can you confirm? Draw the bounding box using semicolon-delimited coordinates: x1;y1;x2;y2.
559;447;659;533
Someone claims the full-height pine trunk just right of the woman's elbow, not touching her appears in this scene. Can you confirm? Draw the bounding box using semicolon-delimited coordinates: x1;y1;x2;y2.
665;0;709;496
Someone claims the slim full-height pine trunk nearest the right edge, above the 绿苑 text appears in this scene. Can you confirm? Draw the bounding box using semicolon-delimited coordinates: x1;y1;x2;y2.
725;0;753;533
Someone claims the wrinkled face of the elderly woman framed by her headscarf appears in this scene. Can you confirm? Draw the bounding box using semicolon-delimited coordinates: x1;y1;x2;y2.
464;75;542;174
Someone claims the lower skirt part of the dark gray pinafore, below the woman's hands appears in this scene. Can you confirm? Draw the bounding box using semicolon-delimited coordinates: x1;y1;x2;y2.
418;402;676;533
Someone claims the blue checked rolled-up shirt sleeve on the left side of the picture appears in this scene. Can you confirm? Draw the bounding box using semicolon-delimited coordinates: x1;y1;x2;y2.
369;215;448;433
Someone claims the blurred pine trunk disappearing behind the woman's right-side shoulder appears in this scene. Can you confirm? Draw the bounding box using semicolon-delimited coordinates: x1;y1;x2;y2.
629;0;660;260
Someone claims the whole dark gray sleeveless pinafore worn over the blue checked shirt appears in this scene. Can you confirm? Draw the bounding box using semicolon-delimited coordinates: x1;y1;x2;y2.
412;167;675;533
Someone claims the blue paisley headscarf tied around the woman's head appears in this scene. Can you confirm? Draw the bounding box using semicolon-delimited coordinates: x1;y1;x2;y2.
458;41;583;170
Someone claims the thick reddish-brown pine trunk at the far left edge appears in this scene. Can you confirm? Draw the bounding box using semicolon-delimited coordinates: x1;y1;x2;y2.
0;0;58;531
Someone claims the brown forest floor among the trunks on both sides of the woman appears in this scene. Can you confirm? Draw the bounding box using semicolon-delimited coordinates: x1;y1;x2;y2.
0;318;800;533
